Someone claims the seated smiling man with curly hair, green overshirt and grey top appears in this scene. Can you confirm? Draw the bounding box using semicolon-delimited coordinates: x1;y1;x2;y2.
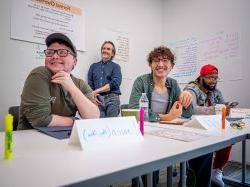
129;46;213;187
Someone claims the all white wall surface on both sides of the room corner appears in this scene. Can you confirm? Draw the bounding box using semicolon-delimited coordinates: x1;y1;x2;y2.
0;0;250;160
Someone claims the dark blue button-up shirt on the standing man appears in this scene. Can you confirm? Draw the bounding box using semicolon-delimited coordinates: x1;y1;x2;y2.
88;60;122;95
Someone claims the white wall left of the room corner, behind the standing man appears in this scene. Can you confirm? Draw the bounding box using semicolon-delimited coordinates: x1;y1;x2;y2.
0;0;163;130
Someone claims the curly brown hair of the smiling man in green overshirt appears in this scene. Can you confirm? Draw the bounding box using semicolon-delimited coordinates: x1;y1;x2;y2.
148;46;175;65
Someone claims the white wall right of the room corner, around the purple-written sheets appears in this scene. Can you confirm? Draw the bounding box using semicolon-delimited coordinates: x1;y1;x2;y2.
163;0;250;162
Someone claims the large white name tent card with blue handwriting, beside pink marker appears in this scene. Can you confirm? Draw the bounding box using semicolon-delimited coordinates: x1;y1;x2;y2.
69;116;143;149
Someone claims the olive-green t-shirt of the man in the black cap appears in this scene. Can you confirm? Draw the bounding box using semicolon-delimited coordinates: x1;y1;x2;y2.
18;66;95;130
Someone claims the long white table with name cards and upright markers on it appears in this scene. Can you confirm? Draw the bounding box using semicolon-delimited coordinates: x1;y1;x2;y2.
0;122;250;187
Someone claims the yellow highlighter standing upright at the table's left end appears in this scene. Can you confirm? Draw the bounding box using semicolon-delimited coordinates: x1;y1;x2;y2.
4;114;13;160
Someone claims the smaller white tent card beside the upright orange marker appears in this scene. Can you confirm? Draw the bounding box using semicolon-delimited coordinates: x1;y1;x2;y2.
185;115;229;130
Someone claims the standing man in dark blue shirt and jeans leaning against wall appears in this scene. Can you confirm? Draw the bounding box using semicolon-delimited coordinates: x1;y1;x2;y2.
88;41;122;117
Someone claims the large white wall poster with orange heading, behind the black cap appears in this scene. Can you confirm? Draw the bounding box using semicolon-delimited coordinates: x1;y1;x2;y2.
11;0;85;51
